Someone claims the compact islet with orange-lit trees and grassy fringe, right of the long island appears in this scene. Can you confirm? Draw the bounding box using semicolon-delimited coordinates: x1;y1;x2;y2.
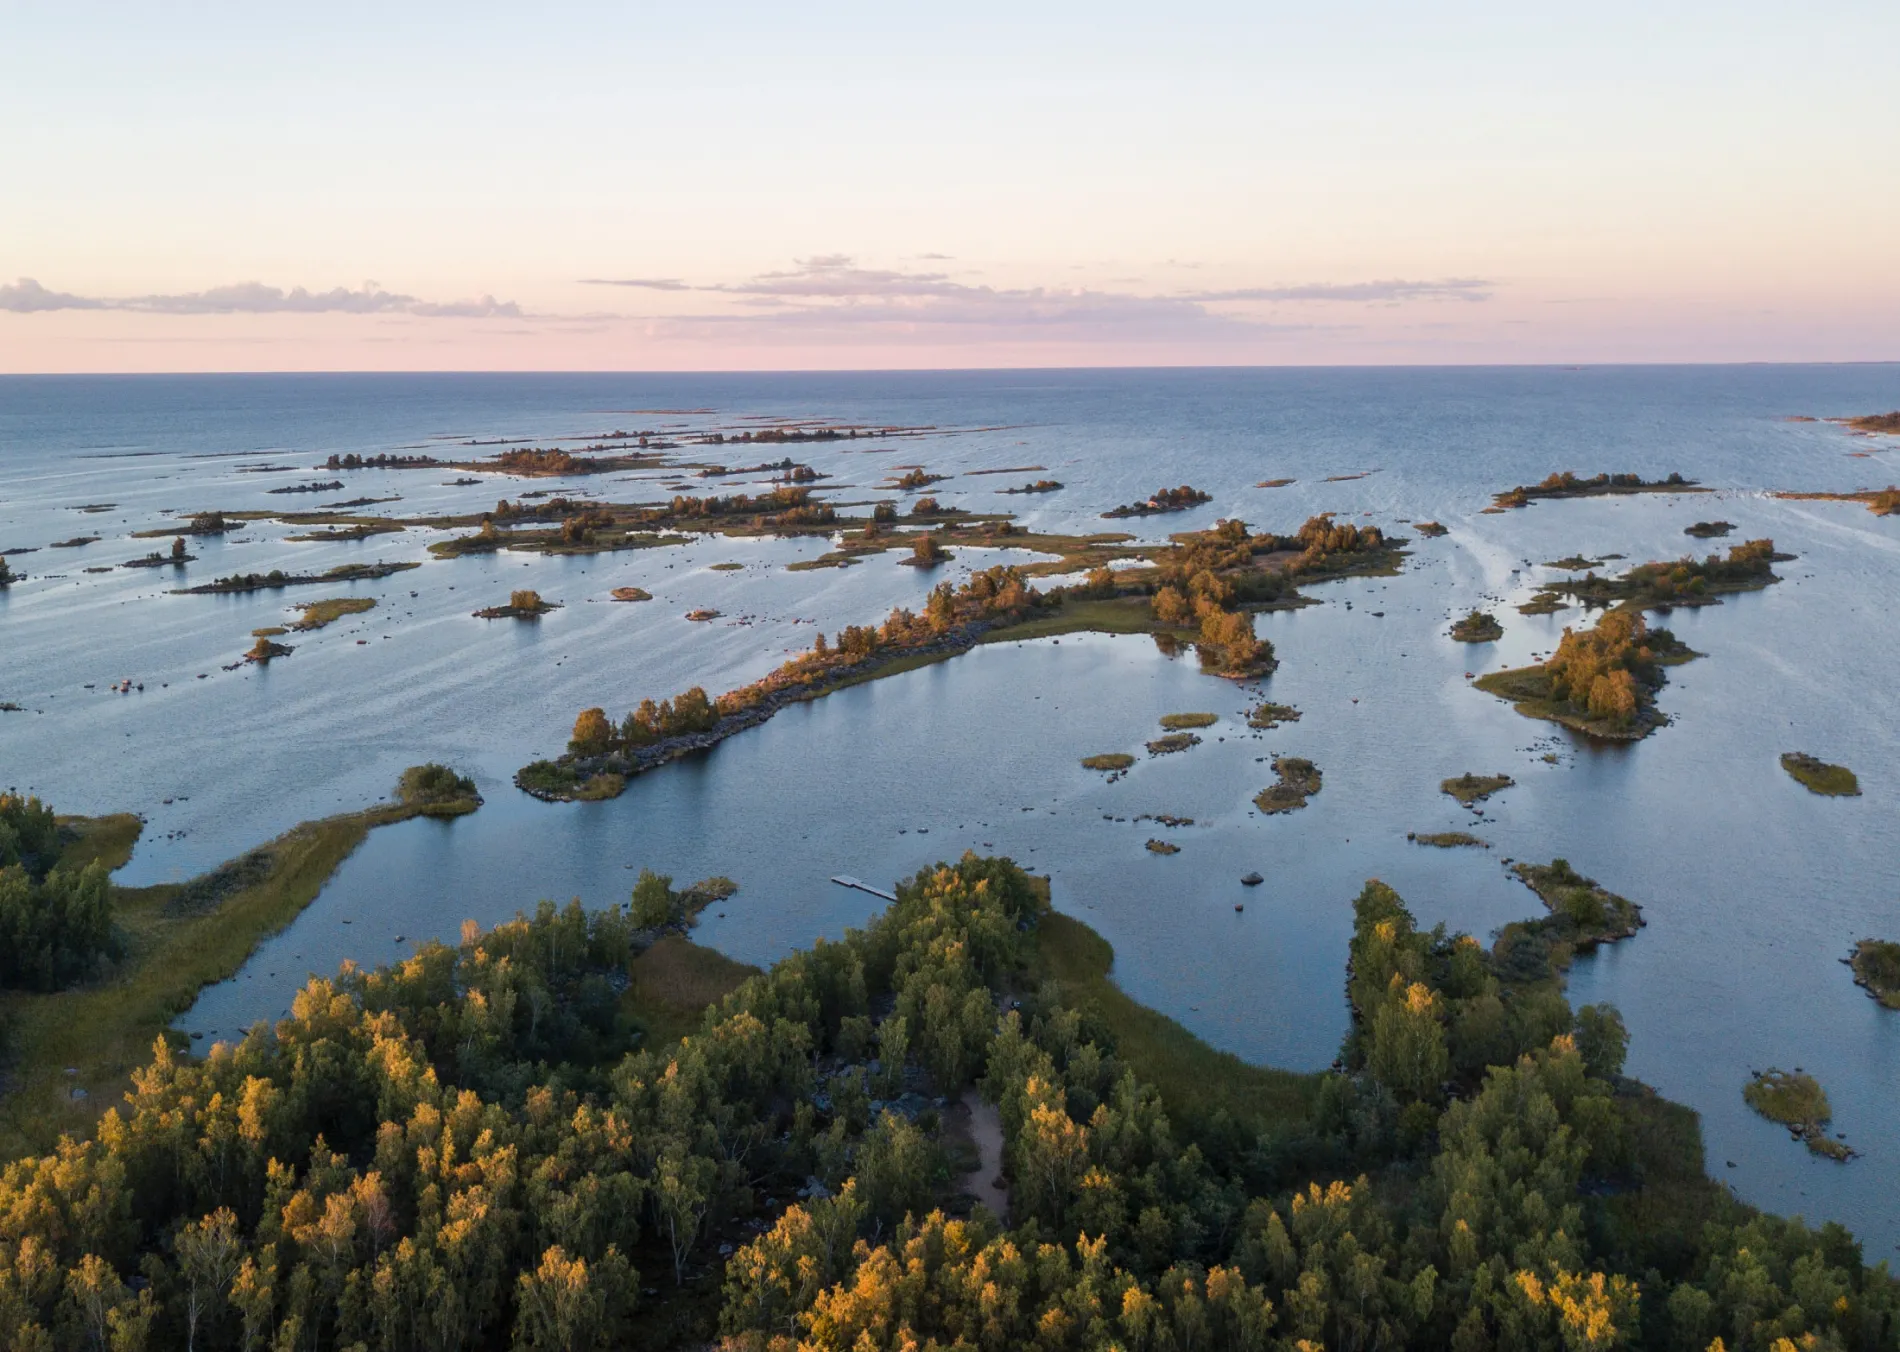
1474;610;1699;741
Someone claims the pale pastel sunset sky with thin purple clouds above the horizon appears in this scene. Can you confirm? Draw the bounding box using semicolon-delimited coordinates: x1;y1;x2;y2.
0;0;1900;372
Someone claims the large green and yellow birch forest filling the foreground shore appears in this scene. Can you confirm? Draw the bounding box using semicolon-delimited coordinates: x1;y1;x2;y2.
0;856;1900;1352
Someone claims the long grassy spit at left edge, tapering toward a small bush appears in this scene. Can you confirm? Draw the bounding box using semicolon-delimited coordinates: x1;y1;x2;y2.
0;805;475;1160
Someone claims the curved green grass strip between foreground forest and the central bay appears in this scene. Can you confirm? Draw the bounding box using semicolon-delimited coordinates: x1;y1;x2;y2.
1034;911;1321;1132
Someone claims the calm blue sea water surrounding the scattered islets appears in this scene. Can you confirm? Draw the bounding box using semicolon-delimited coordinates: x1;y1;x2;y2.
0;366;1900;1259
